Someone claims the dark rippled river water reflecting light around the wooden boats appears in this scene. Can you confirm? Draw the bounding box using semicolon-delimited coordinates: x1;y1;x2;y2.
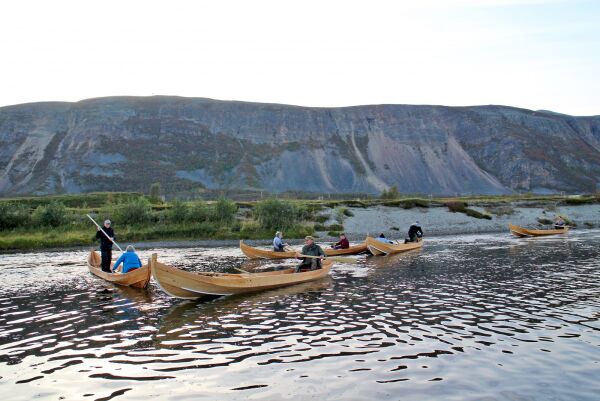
0;230;600;401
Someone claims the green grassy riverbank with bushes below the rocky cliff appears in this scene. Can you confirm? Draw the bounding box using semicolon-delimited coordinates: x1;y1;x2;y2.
0;193;600;250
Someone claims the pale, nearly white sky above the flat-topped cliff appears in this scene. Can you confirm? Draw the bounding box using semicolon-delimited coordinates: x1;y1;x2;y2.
0;0;600;115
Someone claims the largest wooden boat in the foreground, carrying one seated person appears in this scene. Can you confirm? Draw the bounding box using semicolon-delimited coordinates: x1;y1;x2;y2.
150;254;333;299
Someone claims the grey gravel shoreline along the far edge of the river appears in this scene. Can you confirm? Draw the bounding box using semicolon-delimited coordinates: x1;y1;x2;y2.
0;198;600;254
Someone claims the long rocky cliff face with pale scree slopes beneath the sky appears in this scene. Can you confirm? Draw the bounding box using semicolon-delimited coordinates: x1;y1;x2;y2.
0;97;600;196
